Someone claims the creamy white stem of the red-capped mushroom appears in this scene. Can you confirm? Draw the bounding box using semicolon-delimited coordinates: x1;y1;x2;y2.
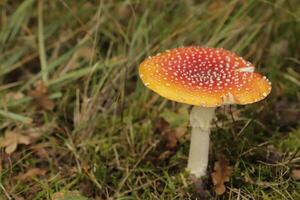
187;107;215;178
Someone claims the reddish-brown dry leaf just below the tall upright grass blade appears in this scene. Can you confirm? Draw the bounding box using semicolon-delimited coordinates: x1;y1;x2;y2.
28;80;54;110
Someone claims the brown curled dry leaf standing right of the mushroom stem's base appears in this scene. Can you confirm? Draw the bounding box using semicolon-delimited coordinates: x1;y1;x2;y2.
211;156;232;195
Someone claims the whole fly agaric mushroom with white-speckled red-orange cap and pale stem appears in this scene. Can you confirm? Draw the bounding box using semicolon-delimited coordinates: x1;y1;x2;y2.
139;46;271;178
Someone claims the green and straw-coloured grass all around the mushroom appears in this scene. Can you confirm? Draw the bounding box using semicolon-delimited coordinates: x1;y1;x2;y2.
0;0;300;200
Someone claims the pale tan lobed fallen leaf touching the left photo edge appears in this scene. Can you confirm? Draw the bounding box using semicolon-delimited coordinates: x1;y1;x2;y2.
0;131;31;154
